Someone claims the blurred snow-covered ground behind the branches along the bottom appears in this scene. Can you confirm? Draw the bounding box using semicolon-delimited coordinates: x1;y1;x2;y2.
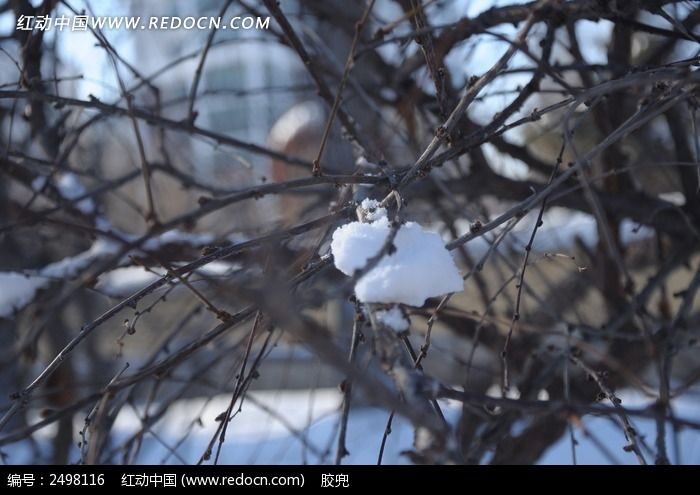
3;389;700;464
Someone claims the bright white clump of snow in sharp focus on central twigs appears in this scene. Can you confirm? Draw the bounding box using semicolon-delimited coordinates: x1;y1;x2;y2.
331;217;463;306
